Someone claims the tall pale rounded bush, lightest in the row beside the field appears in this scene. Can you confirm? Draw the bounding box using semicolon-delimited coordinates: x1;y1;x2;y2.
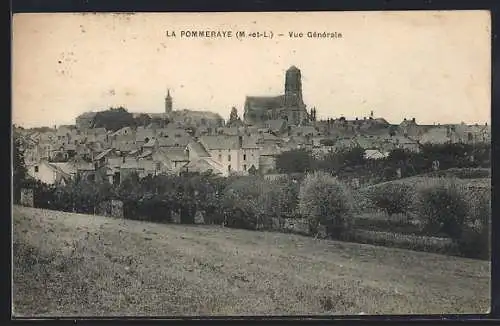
299;172;353;238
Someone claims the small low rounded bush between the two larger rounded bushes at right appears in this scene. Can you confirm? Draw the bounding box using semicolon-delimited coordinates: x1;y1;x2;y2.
367;182;415;216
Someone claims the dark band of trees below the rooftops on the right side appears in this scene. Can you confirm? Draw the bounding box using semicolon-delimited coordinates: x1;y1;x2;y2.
276;143;491;183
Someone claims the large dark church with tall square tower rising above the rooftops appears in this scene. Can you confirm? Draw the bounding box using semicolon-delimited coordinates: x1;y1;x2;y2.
243;66;315;125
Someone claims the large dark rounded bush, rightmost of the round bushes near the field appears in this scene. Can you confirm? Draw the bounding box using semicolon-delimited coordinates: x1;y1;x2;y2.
418;178;469;240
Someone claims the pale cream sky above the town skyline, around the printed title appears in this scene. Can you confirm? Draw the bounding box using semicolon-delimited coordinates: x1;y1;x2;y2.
13;11;491;127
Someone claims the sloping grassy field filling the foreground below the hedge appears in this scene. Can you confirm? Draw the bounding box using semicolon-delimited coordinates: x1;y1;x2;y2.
13;206;490;316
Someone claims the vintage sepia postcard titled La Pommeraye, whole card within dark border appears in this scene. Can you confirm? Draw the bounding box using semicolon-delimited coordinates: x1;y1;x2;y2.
12;11;491;317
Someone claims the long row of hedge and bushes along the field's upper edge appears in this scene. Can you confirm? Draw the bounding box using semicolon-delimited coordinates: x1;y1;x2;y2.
25;172;491;259
